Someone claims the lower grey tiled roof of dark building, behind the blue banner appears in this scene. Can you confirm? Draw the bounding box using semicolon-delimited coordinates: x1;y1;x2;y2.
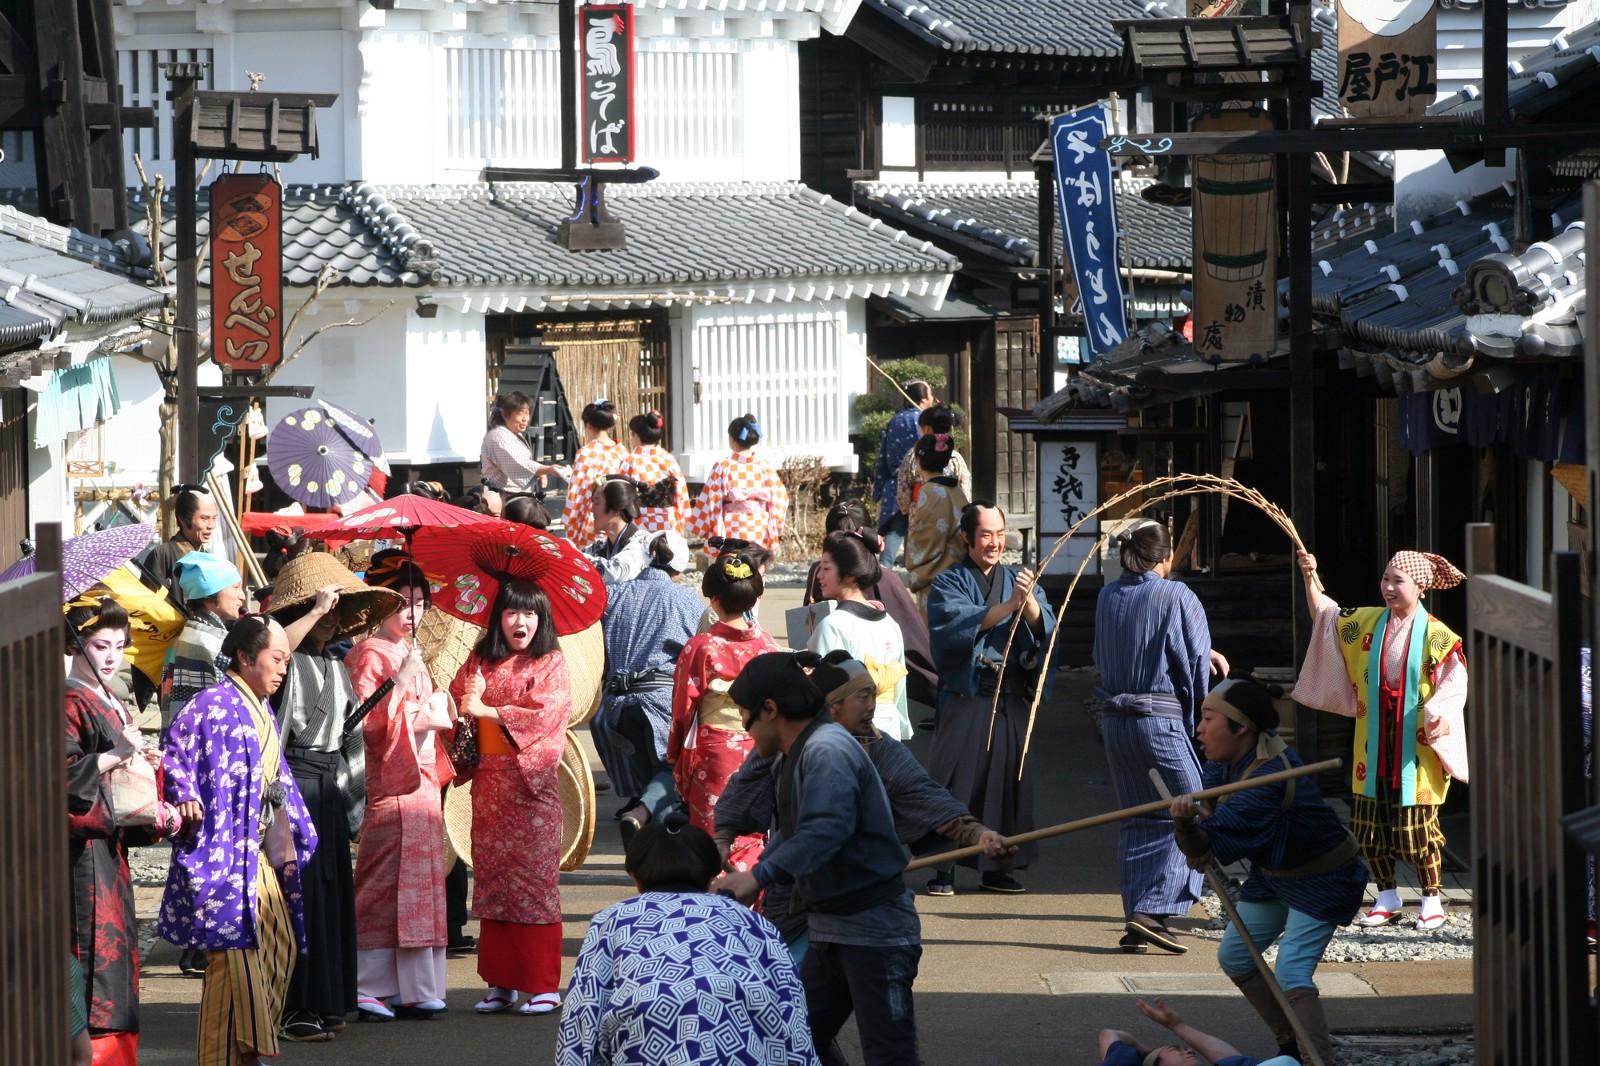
856;178;1192;271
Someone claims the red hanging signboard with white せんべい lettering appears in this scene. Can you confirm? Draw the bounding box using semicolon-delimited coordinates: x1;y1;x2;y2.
211;174;283;371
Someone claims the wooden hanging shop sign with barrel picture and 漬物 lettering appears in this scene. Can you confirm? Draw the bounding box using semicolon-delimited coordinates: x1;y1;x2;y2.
1192;107;1278;363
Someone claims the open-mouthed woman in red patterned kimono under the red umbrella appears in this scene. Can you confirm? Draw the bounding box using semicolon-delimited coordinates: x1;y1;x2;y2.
450;581;576;1015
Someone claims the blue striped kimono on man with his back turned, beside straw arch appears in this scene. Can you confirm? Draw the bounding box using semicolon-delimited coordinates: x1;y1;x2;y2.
1094;570;1211;917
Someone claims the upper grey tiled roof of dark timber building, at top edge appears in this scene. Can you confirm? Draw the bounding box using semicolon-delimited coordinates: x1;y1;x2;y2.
862;0;1182;59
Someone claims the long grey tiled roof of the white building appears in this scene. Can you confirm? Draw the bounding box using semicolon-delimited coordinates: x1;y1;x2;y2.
144;182;960;287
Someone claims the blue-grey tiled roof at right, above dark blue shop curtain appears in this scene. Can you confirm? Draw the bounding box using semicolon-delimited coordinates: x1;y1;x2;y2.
1312;192;1584;392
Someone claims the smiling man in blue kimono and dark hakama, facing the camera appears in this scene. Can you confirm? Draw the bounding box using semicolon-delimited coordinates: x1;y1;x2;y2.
928;499;1056;896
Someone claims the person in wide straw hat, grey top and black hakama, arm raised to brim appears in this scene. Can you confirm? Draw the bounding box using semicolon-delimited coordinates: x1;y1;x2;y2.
270;552;400;1040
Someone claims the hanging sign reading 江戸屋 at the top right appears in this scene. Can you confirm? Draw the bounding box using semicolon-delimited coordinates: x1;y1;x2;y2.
1339;0;1438;118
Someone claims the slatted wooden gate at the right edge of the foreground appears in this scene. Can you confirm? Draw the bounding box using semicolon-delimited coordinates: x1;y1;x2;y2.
1467;523;1600;1066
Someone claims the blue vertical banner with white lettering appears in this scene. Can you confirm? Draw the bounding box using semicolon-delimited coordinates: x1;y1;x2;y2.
1050;104;1128;362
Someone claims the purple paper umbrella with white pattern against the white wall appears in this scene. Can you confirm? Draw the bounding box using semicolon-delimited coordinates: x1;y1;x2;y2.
267;407;382;507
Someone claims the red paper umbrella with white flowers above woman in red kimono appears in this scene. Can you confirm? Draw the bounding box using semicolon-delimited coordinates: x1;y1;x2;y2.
411;519;606;635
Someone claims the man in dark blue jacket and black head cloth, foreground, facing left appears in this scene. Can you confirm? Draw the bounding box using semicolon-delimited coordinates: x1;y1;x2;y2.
712;651;922;1066
